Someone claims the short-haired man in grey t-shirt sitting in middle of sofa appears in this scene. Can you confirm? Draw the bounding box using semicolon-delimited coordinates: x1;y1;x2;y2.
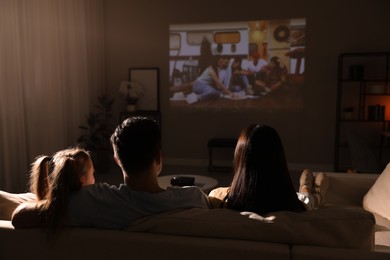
11;117;209;229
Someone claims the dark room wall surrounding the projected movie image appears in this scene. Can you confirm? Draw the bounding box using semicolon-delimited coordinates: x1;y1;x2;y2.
104;0;390;170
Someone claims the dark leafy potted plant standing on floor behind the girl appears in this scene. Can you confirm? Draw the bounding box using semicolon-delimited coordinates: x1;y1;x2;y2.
77;95;116;172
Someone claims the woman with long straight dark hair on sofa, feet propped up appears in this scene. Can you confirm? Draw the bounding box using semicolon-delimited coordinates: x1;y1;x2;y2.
209;124;328;215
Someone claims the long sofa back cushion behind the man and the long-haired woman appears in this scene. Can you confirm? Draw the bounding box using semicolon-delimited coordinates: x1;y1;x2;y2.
127;207;375;251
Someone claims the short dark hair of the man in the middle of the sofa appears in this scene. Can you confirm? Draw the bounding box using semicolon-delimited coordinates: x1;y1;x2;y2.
111;117;161;175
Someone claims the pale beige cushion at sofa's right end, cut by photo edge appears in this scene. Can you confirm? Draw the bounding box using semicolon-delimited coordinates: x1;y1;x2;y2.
363;163;390;220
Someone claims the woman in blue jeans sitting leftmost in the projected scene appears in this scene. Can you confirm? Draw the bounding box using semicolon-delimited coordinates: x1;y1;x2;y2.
186;56;234;104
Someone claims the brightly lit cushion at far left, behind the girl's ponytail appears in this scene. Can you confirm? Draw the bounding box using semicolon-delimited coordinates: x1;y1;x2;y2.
0;190;36;220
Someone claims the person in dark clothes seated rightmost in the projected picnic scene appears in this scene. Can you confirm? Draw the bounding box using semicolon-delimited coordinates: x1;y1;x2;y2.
254;56;287;95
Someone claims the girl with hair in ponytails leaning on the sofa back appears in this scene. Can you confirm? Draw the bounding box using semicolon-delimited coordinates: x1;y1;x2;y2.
12;148;95;232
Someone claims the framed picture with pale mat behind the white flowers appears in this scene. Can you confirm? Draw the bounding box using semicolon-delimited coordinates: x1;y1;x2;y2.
129;67;160;111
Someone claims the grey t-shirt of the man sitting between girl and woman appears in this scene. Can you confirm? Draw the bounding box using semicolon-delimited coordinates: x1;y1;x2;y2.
66;183;209;229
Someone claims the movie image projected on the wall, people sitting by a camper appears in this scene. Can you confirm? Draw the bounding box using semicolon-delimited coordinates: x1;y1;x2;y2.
169;18;306;110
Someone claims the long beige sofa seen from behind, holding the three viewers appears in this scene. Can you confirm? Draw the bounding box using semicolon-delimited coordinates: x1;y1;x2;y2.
0;173;390;259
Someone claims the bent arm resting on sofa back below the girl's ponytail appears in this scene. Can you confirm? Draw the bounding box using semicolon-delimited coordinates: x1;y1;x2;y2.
12;202;47;228
